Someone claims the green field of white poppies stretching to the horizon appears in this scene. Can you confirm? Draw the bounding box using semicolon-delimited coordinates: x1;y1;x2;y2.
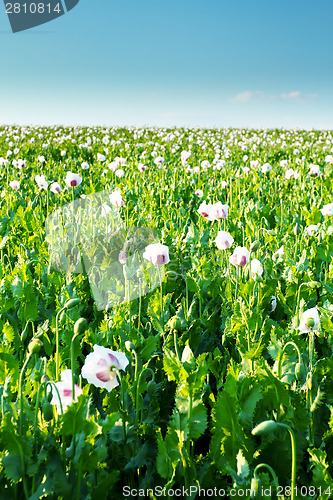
0;126;333;500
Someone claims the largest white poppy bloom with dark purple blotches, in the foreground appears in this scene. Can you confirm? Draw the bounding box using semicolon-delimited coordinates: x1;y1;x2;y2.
81;344;128;391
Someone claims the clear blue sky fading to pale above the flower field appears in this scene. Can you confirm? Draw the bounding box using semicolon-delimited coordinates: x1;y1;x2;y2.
0;0;333;128
